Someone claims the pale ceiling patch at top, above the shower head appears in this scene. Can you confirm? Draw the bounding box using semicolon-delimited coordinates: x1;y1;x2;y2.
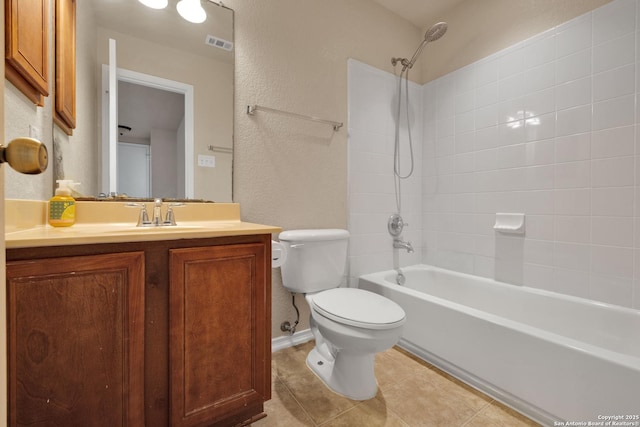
372;0;465;30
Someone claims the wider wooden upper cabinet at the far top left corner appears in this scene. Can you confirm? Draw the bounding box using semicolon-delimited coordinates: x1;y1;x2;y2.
5;0;49;106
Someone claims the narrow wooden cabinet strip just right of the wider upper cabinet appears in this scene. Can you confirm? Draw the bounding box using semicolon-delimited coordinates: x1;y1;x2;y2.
53;0;76;135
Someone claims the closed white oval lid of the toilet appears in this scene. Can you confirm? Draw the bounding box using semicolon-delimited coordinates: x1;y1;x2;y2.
312;288;405;329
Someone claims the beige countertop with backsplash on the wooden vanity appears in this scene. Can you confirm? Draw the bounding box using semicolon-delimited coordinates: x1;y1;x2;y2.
5;200;281;248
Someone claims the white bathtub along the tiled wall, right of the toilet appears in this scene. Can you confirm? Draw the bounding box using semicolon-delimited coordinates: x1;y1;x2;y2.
358;265;640;426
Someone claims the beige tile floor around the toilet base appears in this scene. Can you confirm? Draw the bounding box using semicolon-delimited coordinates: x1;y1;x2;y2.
252;342;538;427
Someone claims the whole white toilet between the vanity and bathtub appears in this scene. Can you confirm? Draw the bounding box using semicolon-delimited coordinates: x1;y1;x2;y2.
279;230;406;400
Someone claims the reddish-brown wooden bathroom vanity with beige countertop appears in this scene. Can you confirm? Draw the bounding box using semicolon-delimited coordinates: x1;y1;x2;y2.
6;203;279;427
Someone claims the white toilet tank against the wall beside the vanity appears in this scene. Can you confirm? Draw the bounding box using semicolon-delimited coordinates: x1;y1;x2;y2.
278;229;349;294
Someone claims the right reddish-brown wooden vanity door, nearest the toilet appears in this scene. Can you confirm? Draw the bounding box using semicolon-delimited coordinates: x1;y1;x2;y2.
169;244;271;427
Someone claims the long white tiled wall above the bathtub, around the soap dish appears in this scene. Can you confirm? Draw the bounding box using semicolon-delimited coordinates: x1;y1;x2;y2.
349;0;640;309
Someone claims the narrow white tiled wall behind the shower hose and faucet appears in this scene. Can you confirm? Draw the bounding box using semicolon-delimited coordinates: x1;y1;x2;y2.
348;60;423;284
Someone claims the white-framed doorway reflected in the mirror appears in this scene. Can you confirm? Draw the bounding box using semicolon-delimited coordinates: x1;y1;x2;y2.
101;65;194;199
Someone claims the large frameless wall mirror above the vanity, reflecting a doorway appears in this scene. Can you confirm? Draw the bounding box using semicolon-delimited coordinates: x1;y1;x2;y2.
85;0;234;202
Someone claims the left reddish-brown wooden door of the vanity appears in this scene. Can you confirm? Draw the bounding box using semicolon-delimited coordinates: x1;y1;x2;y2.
7;252;144;427
